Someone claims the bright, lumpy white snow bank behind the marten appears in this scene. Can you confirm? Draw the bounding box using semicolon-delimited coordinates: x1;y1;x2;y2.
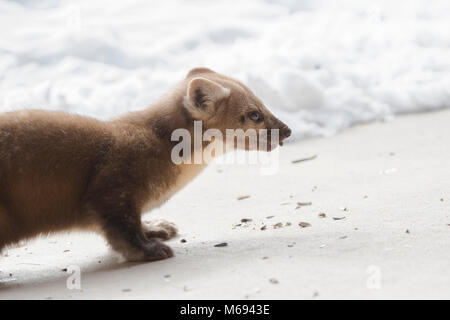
0;0;450;138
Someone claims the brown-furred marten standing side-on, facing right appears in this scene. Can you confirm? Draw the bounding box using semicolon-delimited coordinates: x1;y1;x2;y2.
0;68;290;261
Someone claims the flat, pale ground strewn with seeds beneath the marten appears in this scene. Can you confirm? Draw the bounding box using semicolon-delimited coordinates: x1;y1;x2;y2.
0;110;450;300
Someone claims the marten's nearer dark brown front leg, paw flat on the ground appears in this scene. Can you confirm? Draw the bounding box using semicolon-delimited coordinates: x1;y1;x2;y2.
95;201;173;261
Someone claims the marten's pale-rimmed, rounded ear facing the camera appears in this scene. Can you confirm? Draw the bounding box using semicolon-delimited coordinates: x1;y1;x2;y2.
184;77;230;120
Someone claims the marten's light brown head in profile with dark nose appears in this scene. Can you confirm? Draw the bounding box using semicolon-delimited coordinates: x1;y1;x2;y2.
184;68;291;151
